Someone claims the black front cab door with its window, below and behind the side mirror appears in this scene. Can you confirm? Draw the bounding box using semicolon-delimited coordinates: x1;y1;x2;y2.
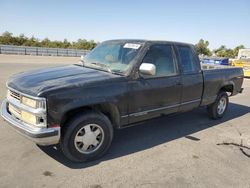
129;44;182;123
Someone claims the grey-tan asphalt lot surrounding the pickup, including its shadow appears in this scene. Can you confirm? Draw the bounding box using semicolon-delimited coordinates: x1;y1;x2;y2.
0;55;250;188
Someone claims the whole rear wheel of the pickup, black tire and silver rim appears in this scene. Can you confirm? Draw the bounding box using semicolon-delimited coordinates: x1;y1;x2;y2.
208;91;228;119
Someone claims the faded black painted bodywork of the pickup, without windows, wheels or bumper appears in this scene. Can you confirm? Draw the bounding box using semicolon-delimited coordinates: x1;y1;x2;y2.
7;40;243;127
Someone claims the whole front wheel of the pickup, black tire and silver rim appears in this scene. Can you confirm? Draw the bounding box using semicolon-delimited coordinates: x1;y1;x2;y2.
60;112;113;162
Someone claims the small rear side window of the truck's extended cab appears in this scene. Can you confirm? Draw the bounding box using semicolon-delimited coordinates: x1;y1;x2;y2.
177;46;198;73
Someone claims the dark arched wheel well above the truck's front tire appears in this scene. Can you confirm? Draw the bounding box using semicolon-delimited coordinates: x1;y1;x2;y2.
61;103;120;127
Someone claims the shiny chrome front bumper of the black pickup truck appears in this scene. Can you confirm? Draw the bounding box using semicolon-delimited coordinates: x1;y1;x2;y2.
1;100;60;145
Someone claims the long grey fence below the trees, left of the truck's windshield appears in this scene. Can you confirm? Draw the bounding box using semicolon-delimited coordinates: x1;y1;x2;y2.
0;45;89;57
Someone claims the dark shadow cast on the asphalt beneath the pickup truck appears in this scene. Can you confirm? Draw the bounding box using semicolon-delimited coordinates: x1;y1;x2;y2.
39;103;250;169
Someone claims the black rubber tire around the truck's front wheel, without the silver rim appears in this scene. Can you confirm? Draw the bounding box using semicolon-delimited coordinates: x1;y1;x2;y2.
60;111;113;162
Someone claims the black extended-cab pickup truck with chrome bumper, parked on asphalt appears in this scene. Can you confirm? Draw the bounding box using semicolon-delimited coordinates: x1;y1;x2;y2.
1;40;243;162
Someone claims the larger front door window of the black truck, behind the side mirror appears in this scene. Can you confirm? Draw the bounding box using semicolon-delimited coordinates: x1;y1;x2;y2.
143;44;177;77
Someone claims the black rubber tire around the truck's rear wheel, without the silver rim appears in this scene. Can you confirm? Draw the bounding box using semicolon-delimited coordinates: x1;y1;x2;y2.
207;91;229;119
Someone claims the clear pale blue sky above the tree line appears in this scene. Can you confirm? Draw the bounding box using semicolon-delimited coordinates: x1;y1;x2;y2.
0;0;250;49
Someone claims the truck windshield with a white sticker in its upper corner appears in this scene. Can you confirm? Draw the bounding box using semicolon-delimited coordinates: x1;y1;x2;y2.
83;41;142;75
